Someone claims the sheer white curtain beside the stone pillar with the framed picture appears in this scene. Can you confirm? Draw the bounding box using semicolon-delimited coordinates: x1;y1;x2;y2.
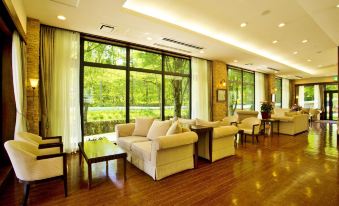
192;57;210;120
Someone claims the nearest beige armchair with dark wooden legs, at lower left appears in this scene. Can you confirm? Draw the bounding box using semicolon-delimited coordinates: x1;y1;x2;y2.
4;140;67;205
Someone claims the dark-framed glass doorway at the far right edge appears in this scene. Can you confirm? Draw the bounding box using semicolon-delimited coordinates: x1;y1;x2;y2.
325;90;338;120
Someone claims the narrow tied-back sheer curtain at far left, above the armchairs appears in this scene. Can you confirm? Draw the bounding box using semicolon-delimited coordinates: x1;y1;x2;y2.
12;31;27;133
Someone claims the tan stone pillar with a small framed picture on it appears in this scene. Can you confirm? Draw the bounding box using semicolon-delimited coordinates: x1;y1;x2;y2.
212;61;227;121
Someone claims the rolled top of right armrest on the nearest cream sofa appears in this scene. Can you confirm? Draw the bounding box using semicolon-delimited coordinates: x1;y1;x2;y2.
152;132;198;150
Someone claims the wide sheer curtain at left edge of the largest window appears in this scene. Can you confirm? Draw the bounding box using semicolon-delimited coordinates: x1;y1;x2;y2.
48;29;81;153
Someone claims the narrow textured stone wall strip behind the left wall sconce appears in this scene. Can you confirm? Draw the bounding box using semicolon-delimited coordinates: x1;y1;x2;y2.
26;18;40;134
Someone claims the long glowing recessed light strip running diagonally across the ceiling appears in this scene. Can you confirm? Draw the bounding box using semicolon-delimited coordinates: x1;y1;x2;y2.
123;0;316;74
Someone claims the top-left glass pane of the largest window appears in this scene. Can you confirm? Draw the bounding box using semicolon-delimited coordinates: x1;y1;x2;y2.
84;41;126;66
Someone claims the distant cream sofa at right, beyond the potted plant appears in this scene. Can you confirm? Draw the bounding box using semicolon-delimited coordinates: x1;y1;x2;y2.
271;108;309;135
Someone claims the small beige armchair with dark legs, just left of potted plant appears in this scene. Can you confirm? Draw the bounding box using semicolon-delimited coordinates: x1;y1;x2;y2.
238;117;261;143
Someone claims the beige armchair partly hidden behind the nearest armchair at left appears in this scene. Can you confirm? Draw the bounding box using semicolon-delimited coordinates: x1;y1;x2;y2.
14;132;63;154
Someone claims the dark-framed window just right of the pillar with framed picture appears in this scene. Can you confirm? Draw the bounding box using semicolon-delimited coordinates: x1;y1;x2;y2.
228;66;255;115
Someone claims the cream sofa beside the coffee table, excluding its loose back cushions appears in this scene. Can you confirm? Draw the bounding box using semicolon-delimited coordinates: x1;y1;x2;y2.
115;120;198;180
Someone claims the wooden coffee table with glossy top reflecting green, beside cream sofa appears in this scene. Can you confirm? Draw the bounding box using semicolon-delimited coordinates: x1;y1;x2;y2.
78;138;127;189
